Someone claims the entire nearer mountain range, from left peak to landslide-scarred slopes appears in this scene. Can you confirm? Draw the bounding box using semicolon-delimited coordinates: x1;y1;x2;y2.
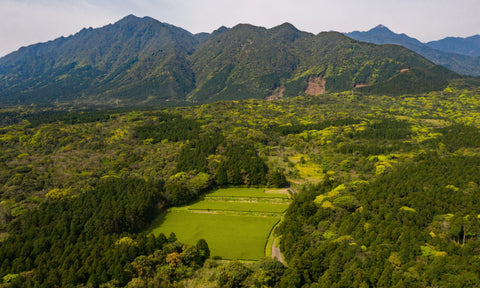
0;15;470;105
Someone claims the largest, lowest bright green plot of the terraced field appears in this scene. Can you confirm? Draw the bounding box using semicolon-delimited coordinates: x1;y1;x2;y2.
152;210;280;260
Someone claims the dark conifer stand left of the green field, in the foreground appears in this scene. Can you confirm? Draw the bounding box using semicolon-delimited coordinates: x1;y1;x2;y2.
0;178;212;287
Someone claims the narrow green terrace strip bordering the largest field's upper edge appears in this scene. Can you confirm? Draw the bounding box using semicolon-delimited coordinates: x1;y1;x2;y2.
188;201;289;213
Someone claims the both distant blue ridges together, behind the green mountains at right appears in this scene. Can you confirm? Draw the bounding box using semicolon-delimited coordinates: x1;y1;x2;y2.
345;25;480;76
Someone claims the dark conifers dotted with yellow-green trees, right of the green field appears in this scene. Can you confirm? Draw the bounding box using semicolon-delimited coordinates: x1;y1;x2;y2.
279;154;480;287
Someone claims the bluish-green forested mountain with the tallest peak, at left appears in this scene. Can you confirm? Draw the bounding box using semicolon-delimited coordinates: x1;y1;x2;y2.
0;15;198;104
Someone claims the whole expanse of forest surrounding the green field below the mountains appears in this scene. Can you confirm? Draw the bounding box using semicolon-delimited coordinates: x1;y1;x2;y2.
0;83;480;287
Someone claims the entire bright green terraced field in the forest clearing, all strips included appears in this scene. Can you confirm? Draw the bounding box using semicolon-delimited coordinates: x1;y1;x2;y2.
152;188;290;260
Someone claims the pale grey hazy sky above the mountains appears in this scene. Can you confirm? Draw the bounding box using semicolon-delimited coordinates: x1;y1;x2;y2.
0;0;480;56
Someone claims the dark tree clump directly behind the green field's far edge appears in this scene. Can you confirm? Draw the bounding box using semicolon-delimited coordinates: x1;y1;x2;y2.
165;139;288;206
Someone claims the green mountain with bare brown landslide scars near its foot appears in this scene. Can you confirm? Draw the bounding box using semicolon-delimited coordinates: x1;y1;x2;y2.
190;23;440;101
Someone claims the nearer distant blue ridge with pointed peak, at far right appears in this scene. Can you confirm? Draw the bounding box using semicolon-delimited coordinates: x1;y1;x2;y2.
345;25;480;76
